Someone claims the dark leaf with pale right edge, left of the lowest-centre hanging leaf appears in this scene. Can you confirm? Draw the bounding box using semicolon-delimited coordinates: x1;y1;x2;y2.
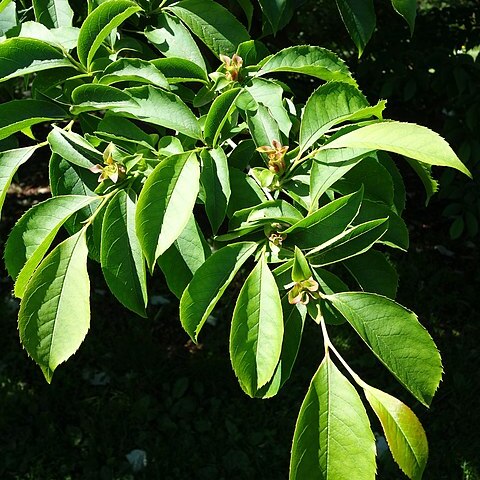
180;242;257;342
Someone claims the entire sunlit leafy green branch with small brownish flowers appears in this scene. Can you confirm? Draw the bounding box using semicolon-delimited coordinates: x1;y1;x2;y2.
0;0;469;479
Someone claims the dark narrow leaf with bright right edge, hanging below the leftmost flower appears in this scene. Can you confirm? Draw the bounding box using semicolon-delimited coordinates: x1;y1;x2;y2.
100;190;148;317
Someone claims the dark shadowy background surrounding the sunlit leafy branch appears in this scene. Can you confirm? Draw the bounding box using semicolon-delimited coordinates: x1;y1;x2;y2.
0;0;480;480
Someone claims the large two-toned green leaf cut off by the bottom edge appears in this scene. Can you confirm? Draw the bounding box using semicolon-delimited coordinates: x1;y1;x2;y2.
290;353;376;480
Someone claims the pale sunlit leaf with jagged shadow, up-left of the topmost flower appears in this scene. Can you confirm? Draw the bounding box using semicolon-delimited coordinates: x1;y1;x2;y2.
145;12;207;75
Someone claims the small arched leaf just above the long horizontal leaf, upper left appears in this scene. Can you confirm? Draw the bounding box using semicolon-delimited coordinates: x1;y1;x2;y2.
98;58;170;90
